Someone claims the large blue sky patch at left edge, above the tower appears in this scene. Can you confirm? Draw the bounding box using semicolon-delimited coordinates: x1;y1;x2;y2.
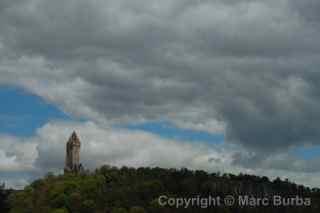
0;87;71;136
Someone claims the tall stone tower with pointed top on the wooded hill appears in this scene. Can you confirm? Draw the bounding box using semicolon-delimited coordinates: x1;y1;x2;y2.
64;132;82;173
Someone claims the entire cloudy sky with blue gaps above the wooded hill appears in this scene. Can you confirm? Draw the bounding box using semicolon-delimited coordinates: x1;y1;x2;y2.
0;0;320;188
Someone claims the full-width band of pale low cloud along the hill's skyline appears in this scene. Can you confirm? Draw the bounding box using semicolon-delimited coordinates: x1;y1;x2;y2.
0;121;319;188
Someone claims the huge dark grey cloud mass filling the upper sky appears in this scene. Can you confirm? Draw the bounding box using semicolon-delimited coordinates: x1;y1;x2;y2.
0;0;320;160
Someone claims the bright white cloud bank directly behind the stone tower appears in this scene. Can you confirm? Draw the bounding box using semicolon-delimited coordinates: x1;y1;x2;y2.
35;122;228;171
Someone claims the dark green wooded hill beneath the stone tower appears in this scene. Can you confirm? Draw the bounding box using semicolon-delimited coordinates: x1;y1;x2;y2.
0;166;320;213
